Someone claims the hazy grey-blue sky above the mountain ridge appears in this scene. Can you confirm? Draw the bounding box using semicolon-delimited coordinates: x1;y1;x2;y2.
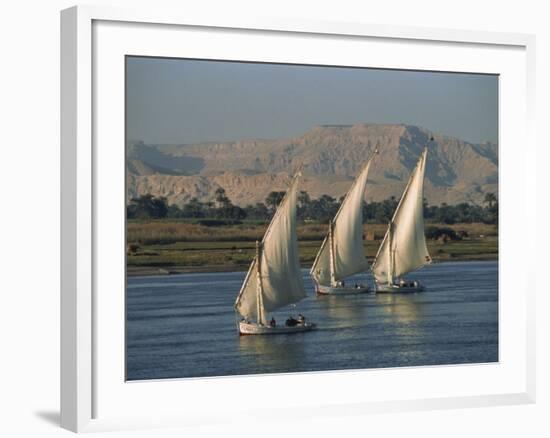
126;57;498;144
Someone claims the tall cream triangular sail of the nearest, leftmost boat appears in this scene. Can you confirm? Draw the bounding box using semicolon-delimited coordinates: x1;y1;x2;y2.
235;173;306;324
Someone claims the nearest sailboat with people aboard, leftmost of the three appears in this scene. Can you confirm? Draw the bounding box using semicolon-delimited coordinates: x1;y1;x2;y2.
235;172;315;335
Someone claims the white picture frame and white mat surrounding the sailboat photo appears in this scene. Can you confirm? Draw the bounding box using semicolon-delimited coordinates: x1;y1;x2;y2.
61;6;536;432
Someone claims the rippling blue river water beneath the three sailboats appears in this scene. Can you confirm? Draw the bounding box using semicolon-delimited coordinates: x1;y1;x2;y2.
126;261;498;380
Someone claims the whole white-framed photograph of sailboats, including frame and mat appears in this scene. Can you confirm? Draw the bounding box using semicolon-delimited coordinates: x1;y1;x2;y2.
61;7;536;431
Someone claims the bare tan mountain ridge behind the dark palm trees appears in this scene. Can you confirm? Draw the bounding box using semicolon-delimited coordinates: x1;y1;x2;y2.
127;123;498;206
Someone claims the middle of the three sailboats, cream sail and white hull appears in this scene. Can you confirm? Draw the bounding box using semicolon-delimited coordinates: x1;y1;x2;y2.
310;151;378;295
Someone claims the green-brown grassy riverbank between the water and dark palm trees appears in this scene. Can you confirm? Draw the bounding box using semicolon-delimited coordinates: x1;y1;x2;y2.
127;220;498;275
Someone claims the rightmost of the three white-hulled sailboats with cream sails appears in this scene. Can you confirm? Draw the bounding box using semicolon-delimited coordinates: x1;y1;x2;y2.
372;146;432;292
